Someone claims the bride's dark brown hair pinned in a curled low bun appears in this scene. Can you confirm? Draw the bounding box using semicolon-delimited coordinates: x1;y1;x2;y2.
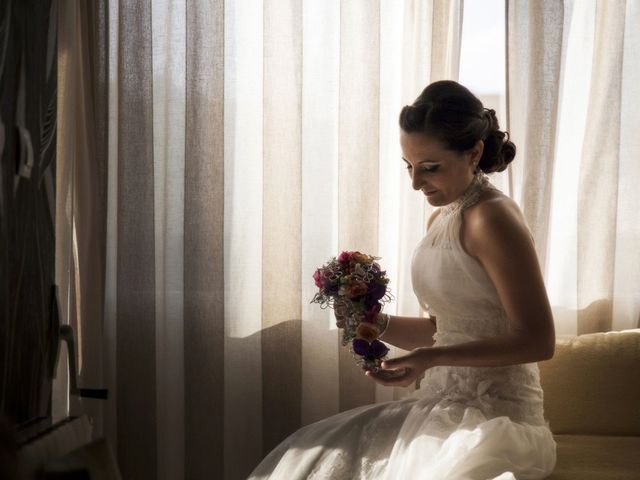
400;80;516;173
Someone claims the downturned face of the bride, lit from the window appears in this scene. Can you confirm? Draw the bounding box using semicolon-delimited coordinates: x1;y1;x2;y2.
400;130;484;207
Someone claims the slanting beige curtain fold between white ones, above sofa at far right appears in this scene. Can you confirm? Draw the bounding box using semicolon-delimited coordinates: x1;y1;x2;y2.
577;0;626;334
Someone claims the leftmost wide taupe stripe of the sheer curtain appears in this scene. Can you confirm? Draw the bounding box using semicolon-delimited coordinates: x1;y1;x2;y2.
116;1;158;479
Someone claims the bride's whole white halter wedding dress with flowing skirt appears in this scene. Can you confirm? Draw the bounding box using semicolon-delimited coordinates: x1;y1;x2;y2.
249;175;556;480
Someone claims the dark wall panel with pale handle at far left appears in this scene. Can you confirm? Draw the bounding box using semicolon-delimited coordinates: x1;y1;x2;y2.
0;0;57;423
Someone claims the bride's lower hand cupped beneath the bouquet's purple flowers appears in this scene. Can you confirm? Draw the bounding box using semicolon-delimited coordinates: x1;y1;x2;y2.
365;347;436;387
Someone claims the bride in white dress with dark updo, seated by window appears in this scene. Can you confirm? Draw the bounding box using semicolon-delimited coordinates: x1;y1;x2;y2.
249;81;556;480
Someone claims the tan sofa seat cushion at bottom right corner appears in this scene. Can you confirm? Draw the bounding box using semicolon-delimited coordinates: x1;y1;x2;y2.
547;435;640;480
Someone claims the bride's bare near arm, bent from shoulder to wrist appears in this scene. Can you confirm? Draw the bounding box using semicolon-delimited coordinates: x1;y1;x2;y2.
429;196;555;366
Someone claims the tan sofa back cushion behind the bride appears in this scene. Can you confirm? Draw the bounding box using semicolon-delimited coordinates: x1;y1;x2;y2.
538;329;640;436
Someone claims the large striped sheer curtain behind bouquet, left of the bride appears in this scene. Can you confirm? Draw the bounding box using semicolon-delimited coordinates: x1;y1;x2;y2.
97;0;462;479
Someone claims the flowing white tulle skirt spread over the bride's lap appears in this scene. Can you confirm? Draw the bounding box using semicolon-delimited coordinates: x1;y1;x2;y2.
249;380;556;480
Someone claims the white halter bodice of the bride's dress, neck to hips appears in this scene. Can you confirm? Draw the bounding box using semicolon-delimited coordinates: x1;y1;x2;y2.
411;174;544;424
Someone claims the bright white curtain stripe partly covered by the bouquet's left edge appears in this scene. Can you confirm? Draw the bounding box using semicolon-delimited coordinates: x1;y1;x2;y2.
299;0;340;425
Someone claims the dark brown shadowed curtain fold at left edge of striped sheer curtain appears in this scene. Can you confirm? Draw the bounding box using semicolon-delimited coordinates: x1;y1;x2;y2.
71;1;108;436
